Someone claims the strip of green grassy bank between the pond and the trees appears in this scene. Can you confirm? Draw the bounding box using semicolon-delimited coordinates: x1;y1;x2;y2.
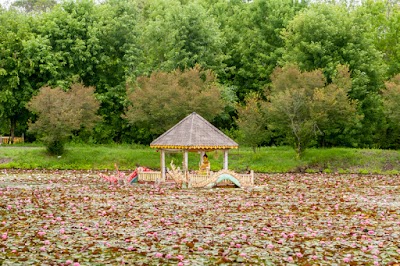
0;145;400;174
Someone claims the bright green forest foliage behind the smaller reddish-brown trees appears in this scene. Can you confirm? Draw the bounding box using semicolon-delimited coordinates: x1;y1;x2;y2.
0;0;400;148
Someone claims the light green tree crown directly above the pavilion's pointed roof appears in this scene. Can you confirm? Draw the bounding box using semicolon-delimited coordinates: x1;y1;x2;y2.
140;0;225;75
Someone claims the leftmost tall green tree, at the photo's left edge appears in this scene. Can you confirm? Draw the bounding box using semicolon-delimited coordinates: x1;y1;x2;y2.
0;10;58;143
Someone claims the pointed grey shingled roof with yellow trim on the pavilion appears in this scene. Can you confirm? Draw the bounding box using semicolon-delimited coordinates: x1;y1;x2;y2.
150;113;239;150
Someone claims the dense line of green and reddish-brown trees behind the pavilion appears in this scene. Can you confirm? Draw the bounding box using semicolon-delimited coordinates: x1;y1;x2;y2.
0;0;400;154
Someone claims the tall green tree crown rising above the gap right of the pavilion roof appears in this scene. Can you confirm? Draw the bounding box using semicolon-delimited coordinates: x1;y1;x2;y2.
220;0;306;100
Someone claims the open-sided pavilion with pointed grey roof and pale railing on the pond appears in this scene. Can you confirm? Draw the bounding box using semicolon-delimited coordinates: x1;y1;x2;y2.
139;112;254;187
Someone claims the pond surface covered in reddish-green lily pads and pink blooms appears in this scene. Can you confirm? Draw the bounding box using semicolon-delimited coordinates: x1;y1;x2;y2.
0;170;400;266
